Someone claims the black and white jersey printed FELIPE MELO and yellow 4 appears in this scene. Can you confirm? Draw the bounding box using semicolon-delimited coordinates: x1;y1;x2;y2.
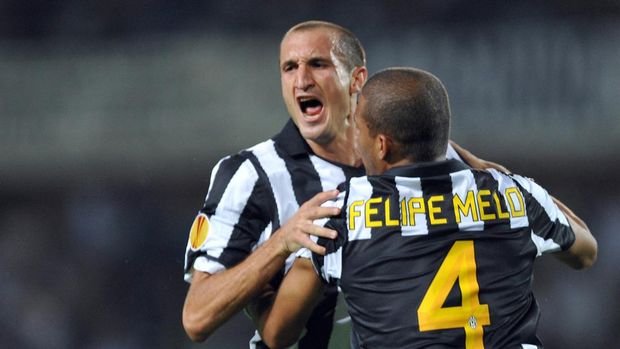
300;160;575;348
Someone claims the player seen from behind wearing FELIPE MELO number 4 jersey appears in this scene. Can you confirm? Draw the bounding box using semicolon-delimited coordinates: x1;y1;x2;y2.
261;68;597;349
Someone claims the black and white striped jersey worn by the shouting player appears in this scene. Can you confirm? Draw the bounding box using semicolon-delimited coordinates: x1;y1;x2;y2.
185;120;459;348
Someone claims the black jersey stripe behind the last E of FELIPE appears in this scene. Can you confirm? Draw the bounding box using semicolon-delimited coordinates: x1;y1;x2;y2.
420;174;459;234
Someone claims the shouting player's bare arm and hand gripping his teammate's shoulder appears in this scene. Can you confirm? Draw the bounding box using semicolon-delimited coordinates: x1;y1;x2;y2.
183;190;340;341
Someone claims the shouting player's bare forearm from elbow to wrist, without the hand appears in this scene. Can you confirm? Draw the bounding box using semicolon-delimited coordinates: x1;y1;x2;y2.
183;241;288;341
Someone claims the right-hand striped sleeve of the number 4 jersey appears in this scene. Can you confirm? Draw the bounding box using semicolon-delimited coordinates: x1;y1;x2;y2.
512;175;575;256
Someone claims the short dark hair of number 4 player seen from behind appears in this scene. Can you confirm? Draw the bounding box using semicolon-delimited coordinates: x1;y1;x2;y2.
362;68;450;162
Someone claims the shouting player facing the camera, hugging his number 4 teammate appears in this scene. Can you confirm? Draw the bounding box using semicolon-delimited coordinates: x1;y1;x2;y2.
183;21;502;349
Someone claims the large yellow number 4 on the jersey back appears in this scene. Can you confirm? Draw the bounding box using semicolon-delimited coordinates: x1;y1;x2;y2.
418;240;491;349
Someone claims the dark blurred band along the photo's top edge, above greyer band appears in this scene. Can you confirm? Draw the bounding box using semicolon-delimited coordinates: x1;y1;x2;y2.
0;0;620;39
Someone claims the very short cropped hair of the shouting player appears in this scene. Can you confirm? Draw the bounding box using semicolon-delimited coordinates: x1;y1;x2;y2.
284;21;366;71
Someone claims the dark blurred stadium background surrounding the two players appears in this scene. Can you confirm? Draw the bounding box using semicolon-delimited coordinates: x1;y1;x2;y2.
0;0;620;349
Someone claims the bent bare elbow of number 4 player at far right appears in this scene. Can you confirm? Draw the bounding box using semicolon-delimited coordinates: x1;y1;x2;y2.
553;198;598;269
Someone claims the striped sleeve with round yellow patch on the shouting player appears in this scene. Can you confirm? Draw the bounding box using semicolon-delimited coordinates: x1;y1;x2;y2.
184;154;271;282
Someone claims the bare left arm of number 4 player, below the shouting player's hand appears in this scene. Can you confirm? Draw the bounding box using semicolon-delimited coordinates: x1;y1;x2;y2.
255;258;323;349
